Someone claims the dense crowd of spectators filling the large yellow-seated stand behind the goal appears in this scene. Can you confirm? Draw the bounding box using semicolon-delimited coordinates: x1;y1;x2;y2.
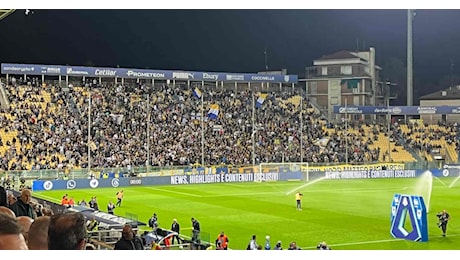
0;77;420;171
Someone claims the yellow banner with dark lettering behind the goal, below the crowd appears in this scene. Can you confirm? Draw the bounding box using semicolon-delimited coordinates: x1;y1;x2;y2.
308;163;404;172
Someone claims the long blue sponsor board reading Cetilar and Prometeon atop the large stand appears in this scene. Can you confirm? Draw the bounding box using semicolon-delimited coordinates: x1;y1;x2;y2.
1;63;298;83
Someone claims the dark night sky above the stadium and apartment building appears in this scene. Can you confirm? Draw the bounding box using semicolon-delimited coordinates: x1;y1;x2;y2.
0;9;460;102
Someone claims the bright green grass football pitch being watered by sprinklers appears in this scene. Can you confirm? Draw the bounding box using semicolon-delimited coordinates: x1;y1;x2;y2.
34;176;460;250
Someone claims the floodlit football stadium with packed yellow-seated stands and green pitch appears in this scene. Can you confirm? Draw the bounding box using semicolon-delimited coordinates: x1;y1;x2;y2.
0;8;460;250
